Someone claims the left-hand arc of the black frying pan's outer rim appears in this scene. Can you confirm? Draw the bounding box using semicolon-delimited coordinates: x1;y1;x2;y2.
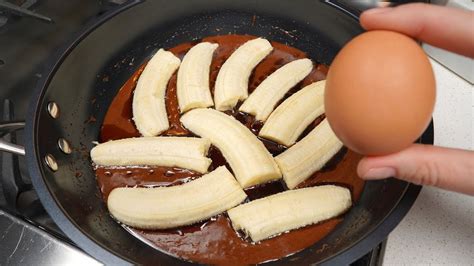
24;0;144;265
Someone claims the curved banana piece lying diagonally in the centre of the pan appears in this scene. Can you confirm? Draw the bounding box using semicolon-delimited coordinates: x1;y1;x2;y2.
181;108;281;188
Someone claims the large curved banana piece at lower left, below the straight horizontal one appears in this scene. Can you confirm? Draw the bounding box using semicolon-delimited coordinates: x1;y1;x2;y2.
107;166;247;229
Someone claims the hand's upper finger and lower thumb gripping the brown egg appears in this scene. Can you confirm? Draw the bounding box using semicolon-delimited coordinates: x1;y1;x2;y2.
357;4;474;195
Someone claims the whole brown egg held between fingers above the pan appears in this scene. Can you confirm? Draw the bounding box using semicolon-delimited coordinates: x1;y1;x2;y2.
325;31;436;155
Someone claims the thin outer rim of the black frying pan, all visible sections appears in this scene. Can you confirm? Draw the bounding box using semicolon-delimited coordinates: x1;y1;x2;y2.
25;0;433;265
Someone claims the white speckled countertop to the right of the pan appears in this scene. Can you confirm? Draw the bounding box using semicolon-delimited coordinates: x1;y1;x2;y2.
383;61;474;265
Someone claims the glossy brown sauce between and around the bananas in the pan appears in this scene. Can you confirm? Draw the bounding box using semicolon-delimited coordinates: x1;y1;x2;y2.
96;35;364;264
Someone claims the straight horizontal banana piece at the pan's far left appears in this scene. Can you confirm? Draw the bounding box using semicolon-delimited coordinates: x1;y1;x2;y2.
91;137;211;173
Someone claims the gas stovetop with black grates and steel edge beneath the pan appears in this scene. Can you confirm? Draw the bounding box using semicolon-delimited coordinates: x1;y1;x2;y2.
0;0;385;265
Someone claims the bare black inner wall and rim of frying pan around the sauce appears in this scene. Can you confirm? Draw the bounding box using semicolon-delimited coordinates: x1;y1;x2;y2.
0;0;433;264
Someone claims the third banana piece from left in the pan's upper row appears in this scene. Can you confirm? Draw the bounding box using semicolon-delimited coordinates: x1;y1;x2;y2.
214;38;273;111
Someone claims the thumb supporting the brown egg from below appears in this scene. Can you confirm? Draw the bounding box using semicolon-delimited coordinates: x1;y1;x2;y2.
357;144;474;195
